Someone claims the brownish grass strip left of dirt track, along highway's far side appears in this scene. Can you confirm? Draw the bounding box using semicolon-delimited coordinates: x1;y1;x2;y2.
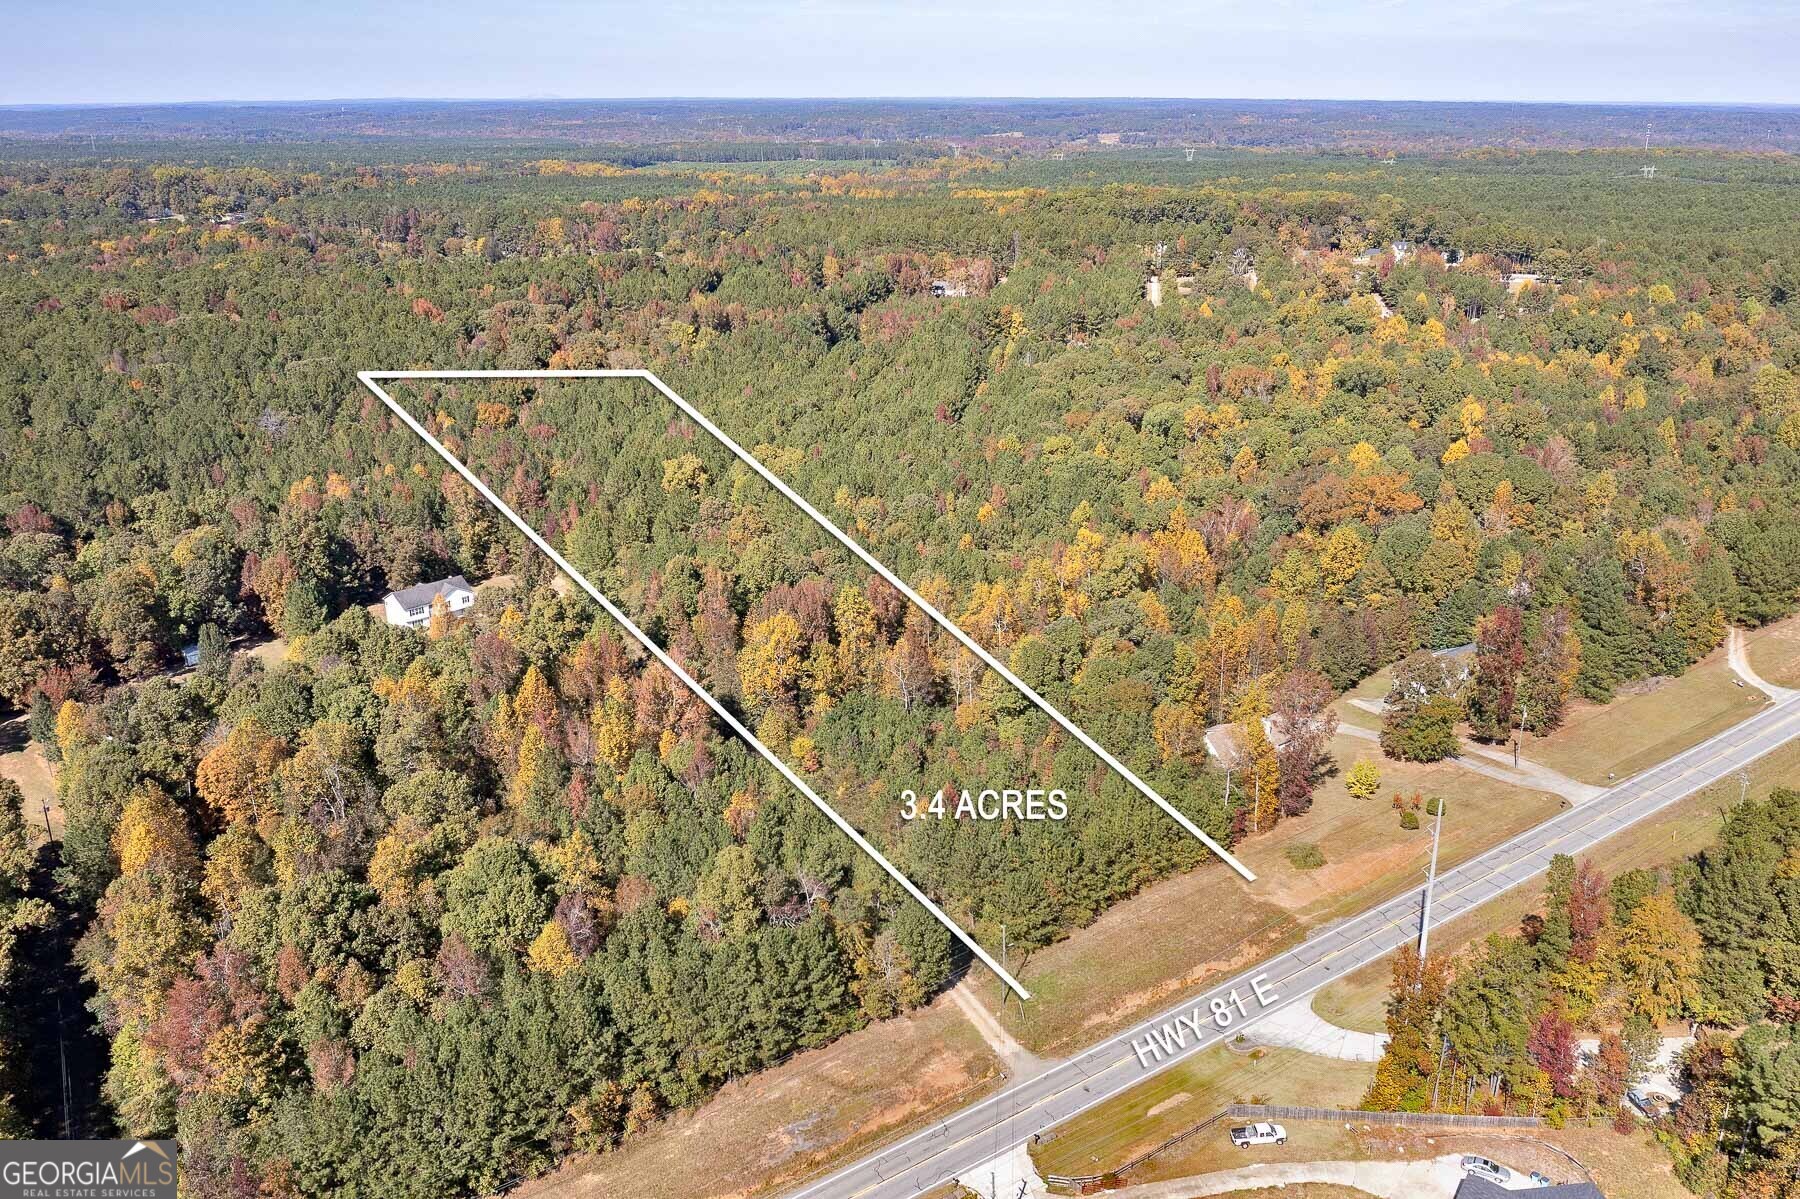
513;996;1001;1199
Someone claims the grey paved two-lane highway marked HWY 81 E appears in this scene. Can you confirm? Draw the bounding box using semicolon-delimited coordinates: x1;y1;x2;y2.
790;699;1800;1199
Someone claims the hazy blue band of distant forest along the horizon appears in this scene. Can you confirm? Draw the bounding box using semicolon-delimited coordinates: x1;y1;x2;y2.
0;99;1800;157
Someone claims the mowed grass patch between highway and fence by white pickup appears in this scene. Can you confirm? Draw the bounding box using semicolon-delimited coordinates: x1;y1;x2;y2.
1031;1046;1375;1181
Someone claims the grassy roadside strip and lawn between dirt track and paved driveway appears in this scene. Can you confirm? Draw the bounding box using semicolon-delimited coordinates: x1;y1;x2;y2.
977;735;1561;1053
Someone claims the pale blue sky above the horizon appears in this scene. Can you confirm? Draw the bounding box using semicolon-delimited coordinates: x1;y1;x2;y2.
14;0;1800;104
